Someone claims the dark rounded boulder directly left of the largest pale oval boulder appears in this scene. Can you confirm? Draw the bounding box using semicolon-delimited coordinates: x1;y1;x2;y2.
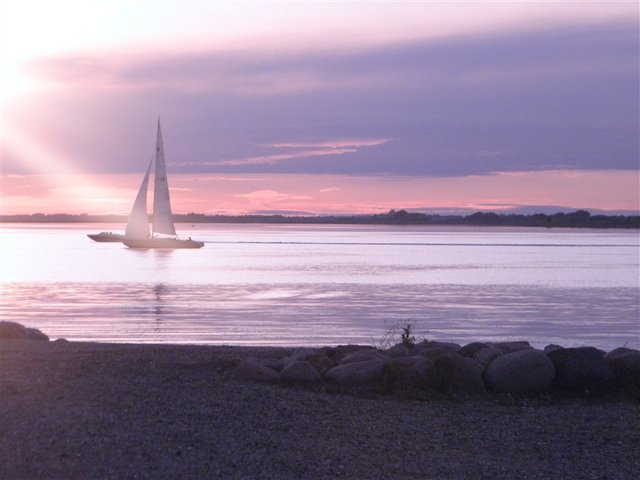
425;351;485;392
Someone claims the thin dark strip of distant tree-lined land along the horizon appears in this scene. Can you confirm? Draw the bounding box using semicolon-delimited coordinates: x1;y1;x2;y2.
0;210;640;229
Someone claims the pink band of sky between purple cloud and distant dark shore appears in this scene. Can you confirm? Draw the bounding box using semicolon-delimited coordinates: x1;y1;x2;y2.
2;170;640;214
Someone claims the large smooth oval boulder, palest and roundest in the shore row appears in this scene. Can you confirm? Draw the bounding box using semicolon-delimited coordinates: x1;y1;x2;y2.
484;349;555;395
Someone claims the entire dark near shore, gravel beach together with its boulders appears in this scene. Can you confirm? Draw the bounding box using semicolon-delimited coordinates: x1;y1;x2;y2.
0;322;640;479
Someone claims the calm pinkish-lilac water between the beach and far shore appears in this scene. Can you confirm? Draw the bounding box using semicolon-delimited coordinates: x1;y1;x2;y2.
0;224;640;350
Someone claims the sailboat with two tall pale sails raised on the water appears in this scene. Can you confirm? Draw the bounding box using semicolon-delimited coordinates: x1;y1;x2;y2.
122;119;204;248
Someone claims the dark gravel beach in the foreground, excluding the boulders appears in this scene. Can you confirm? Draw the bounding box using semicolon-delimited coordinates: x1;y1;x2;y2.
0;341;640;480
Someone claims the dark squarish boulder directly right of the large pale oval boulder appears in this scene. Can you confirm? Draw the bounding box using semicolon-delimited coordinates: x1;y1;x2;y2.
547;347;615;390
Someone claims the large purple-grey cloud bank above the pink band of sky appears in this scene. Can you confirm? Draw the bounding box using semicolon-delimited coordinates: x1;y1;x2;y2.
8;17;640;176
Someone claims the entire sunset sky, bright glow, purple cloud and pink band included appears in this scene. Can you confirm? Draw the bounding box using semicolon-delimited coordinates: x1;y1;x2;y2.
0;0;640;214
